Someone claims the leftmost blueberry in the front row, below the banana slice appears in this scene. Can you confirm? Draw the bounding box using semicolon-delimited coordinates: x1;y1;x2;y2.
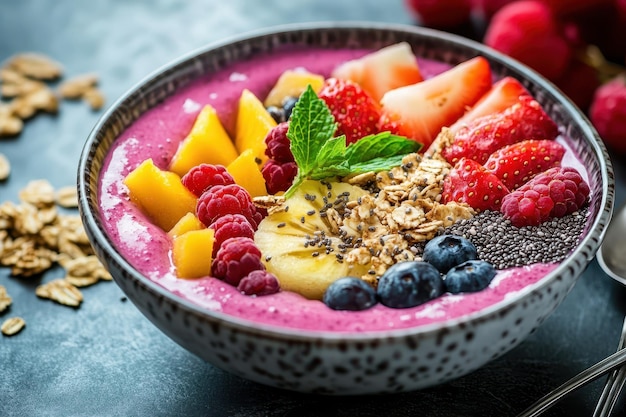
323;277;377;311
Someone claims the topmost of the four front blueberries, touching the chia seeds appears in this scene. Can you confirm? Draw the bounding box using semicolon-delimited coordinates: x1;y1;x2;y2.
422;235;478;274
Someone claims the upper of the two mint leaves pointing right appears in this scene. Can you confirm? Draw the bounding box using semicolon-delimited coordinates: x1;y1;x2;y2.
346;132;422;165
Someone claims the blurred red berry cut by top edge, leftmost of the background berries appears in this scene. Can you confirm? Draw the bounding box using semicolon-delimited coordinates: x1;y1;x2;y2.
405;0;472;28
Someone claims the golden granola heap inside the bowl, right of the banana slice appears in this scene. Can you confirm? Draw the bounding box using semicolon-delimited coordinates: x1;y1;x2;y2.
340;141;475;284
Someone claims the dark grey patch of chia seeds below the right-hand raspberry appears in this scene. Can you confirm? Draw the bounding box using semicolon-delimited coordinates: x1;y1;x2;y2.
441;207;588;269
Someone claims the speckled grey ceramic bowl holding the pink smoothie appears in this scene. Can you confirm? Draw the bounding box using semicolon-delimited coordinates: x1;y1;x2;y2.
78;23;614;394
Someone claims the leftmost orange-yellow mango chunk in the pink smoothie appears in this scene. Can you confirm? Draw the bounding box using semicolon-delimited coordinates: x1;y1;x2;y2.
124;159;197;231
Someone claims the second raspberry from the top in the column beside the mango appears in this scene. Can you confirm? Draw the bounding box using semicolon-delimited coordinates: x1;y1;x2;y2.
196;184;263;230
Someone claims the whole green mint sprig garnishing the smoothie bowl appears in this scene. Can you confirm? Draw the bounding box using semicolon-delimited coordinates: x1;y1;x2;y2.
285;85;422;198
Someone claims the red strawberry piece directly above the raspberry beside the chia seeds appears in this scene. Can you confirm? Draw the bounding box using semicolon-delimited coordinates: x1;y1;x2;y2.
485;140;565;191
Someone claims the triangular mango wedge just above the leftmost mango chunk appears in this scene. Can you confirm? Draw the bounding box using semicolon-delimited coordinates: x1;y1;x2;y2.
169;104;239;177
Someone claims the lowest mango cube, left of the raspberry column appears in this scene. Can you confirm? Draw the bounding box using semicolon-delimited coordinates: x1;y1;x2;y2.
172;228;215;278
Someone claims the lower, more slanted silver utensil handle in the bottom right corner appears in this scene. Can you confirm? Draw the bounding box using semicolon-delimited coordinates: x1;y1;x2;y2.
517;349;626;417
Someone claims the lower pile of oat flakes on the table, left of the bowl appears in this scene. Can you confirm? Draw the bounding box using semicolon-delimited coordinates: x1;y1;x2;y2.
0;180;112;335
